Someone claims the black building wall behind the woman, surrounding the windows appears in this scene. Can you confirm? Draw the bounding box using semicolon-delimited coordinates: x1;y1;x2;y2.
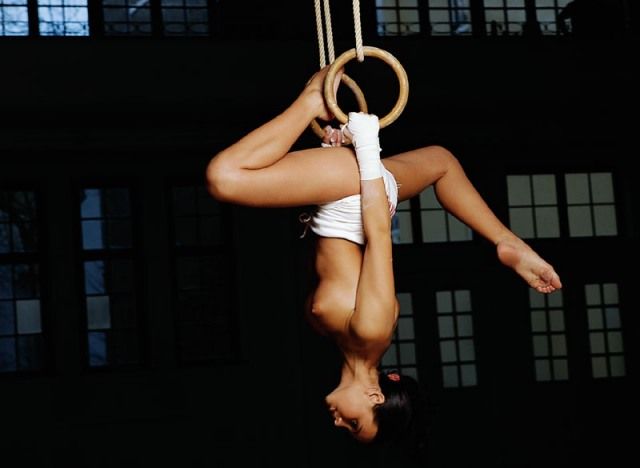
0;2;640;467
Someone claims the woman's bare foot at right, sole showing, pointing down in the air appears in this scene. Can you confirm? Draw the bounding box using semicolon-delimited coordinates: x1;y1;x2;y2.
497;239;562;293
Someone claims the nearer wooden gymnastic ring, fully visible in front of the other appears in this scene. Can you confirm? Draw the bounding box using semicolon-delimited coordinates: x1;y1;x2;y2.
324;46;409;128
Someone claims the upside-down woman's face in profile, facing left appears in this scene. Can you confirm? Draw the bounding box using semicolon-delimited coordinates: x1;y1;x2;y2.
325;384;381;442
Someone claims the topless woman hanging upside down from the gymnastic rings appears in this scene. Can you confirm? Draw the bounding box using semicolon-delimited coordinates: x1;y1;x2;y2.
206;67;562;454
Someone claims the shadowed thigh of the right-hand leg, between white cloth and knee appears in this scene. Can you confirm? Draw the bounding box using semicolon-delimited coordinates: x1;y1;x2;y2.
382;146;455;201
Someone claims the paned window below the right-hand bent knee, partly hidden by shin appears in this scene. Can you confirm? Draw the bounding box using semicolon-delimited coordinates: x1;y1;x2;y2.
420;187;473;243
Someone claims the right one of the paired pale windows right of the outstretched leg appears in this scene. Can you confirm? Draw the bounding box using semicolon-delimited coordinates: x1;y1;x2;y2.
565;172;618;237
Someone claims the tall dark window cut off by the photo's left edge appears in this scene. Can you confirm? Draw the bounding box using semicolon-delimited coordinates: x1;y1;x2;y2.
0;190;44;372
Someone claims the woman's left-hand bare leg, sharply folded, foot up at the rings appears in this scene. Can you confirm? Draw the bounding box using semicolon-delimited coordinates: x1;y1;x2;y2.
206;68;360;207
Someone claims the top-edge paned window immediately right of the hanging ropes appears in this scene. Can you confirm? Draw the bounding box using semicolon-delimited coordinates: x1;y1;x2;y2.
376;0;420;36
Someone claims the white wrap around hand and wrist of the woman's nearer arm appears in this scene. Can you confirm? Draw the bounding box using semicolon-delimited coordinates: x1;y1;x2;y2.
347;112;382;180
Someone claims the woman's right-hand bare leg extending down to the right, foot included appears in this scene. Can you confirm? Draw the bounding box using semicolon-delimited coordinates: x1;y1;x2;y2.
383;146;562;293
